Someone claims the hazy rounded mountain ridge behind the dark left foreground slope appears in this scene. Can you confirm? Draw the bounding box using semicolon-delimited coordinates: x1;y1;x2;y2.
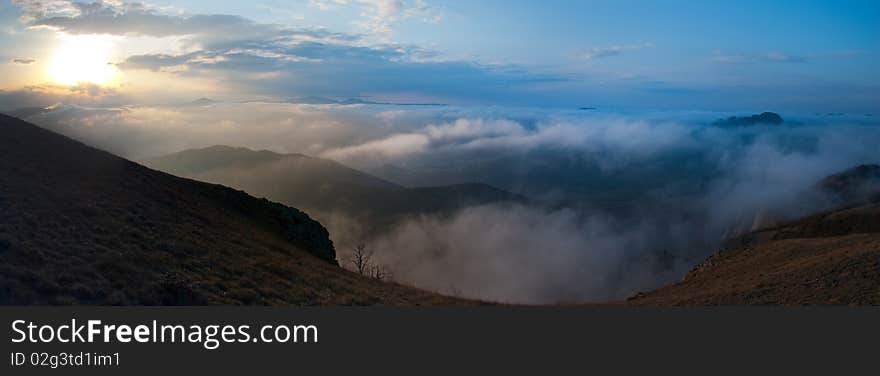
143;146;526;227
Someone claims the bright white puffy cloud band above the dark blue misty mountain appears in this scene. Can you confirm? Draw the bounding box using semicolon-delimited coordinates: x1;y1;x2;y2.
321;117;689;168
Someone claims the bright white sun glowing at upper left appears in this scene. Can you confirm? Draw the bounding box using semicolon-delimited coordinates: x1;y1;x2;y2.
49;35;117;86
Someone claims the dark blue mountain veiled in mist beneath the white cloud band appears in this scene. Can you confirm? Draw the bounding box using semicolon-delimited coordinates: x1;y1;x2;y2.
368;149;719;216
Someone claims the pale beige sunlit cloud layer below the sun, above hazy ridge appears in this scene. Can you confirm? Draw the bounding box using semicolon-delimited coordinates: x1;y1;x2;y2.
0;100;405;159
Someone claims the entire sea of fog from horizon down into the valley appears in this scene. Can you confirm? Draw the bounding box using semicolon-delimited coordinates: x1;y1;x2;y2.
12;103;880;303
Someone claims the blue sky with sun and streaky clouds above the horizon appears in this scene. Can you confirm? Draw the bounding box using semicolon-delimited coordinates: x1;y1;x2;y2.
0;0;880;114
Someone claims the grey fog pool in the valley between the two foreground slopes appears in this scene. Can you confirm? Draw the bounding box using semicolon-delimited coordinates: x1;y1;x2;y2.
369;205;688;304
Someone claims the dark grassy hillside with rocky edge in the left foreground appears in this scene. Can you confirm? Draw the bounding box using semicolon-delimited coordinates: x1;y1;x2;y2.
0;115;462;305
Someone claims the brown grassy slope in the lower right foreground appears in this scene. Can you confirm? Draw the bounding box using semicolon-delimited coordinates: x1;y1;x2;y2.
627;203;880;305
